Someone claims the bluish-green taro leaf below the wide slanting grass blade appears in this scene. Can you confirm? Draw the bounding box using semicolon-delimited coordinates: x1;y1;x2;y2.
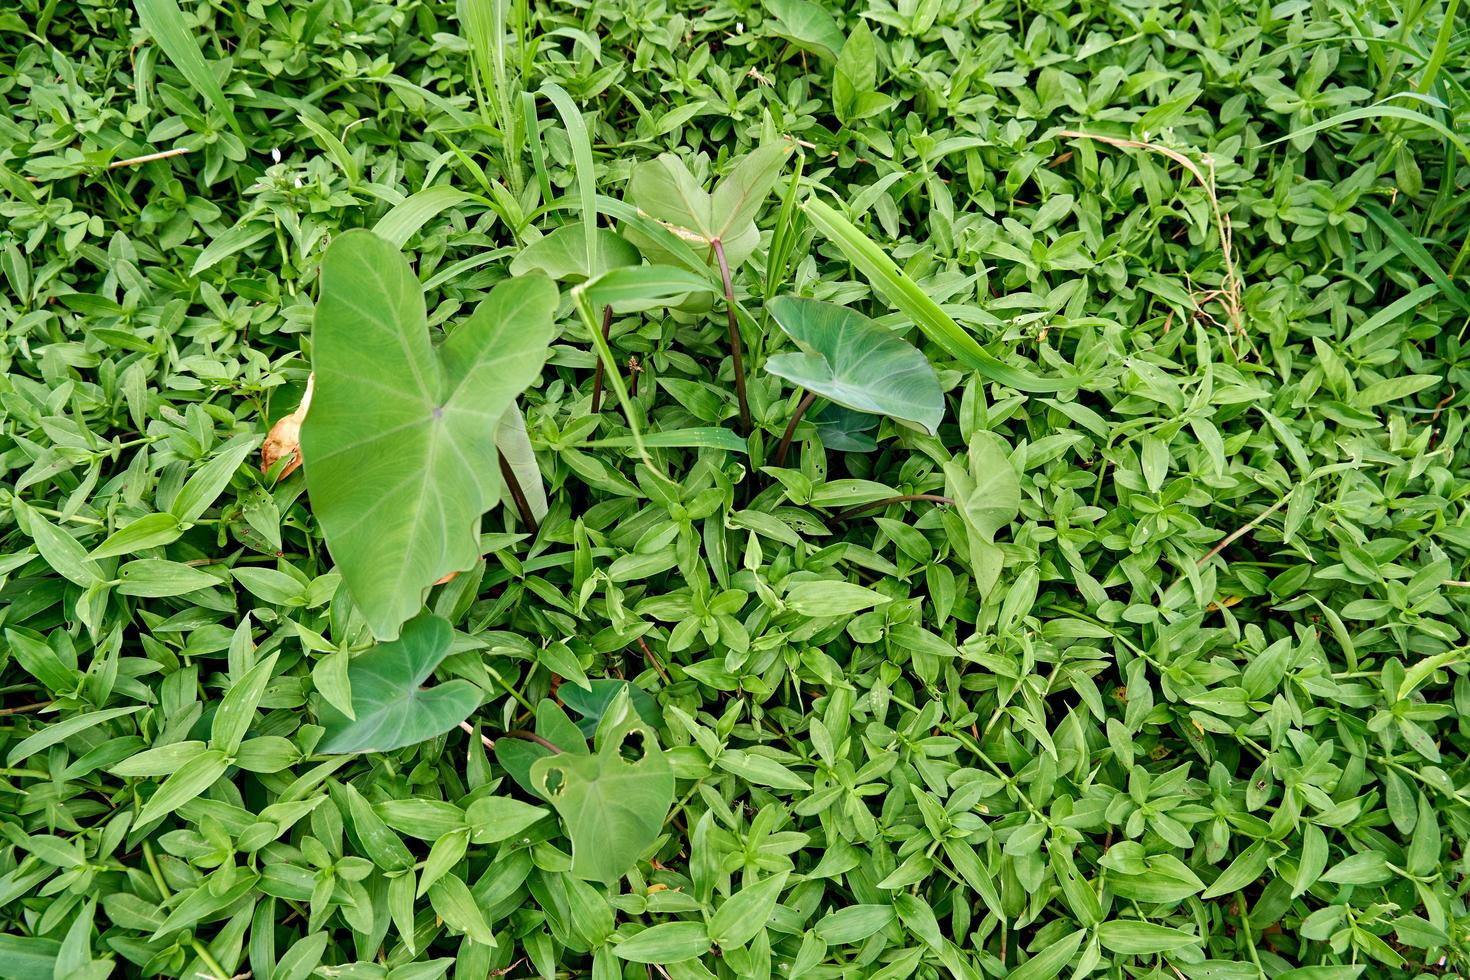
766;297;944;433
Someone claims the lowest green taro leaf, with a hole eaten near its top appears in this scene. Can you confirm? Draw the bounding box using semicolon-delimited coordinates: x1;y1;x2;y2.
531;717;676;881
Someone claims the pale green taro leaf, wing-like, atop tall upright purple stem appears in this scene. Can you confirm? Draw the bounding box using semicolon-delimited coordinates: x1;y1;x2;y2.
623;143;792;270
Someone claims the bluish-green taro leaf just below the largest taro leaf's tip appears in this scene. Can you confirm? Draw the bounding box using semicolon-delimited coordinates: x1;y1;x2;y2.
316;613;481;754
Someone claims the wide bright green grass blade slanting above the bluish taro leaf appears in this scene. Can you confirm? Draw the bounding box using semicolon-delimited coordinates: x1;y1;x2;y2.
801;197;1080;392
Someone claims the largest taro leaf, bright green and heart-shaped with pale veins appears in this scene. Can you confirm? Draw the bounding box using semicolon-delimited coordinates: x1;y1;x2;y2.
301;231;557;639
